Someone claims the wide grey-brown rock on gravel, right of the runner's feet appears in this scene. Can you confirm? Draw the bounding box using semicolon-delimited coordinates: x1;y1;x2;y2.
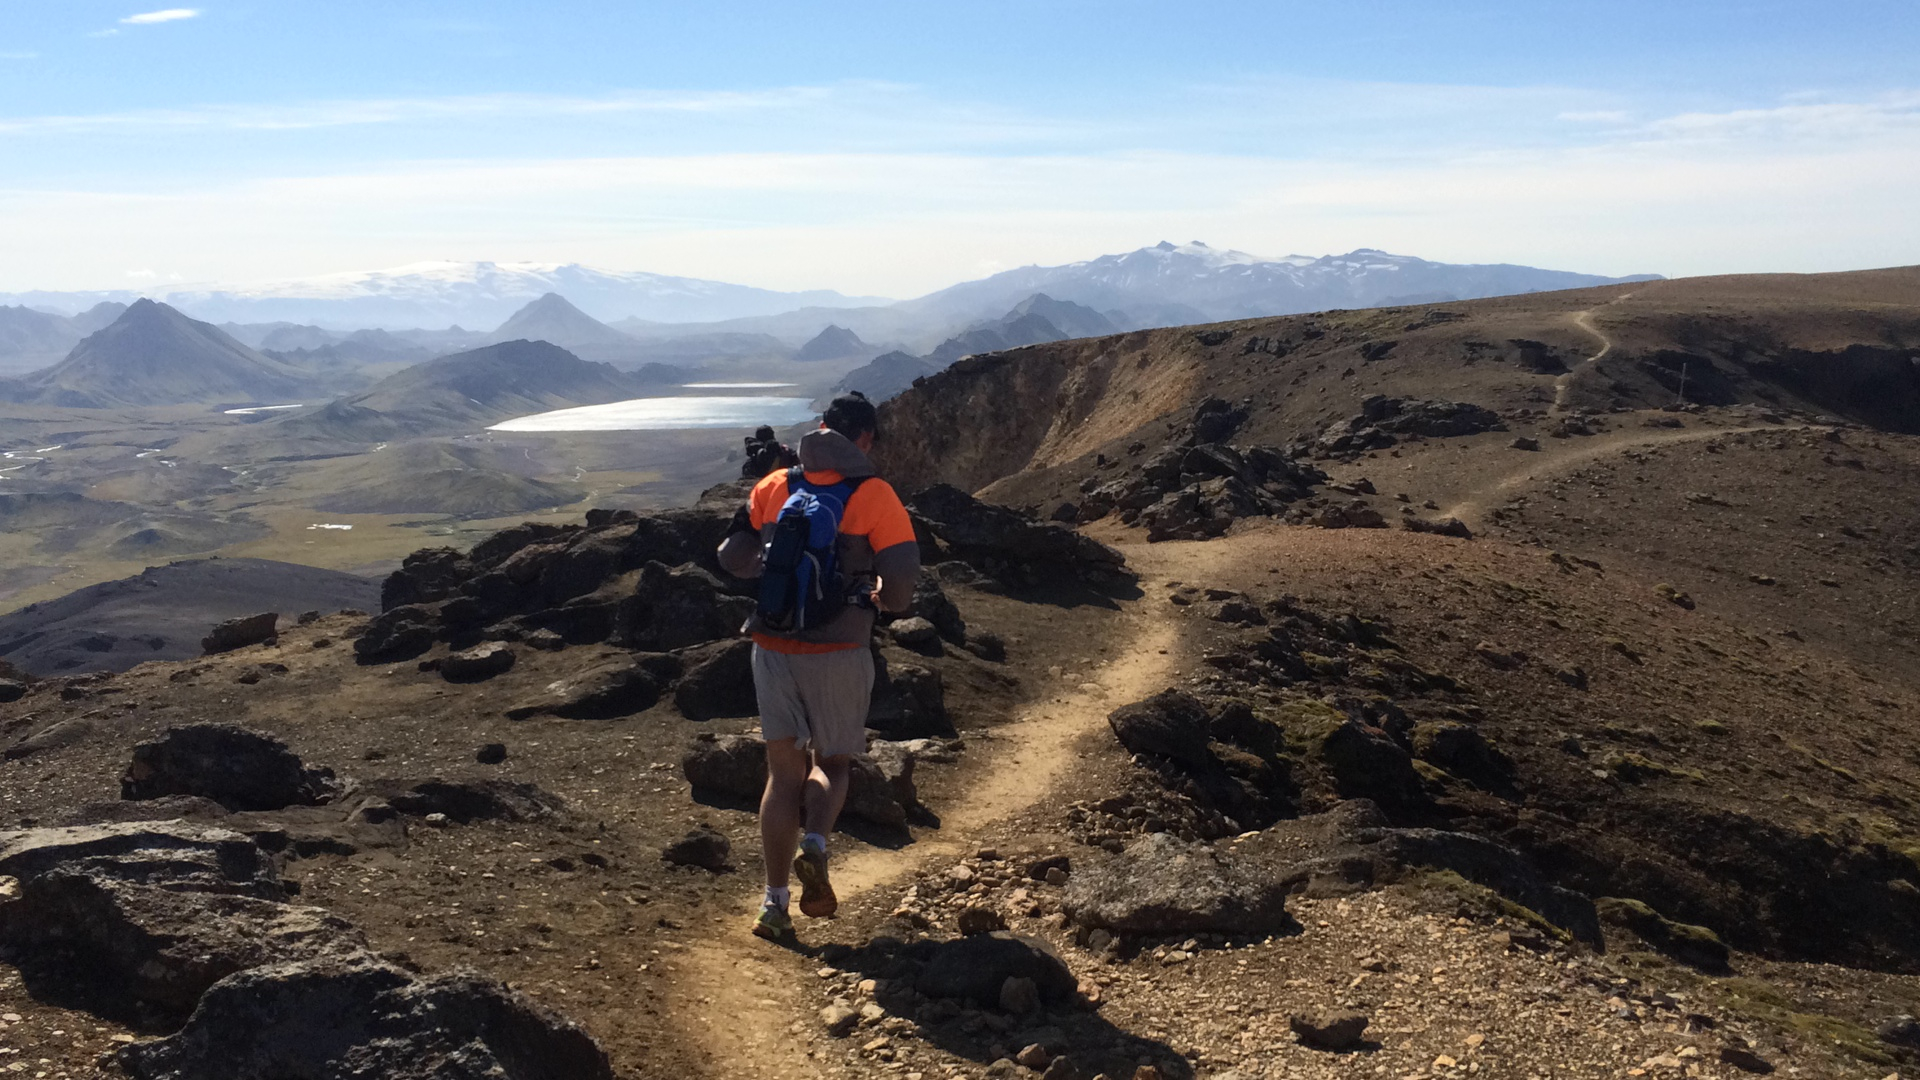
1060;832;1298;934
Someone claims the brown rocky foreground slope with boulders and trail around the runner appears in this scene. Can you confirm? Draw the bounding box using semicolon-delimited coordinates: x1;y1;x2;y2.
0;276;1920;1080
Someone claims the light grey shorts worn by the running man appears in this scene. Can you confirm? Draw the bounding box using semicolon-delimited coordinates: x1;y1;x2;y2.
753;646;874;757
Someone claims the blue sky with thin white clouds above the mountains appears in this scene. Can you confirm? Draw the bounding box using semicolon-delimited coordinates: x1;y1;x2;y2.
0;0;1920;296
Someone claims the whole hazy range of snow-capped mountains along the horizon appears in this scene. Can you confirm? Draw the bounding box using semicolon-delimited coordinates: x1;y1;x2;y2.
0;242;1634;336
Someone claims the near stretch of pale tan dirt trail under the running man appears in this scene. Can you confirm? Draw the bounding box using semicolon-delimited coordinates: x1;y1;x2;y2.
662;557;1190;1078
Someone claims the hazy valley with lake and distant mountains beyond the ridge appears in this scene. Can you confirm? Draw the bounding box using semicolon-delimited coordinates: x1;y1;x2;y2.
0;242;1651;607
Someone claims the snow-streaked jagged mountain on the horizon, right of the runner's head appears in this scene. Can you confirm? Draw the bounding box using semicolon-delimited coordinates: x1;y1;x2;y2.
900;240;1644;325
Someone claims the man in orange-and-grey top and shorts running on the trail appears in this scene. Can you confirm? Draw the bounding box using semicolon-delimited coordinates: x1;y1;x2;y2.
720;392;920;938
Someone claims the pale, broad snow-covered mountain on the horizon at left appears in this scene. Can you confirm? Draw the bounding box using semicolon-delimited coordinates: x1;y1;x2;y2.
6;261;887;329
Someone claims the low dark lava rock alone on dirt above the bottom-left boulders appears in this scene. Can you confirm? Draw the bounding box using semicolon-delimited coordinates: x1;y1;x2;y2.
121;724;340;811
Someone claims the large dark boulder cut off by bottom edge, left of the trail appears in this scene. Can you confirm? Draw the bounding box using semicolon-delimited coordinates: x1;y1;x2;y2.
119;955;612;1080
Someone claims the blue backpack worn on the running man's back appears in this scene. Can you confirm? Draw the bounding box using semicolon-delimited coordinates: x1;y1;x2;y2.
760;467;866;634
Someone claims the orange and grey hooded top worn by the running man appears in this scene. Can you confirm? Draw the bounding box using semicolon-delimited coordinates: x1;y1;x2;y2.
720;429;920;653
